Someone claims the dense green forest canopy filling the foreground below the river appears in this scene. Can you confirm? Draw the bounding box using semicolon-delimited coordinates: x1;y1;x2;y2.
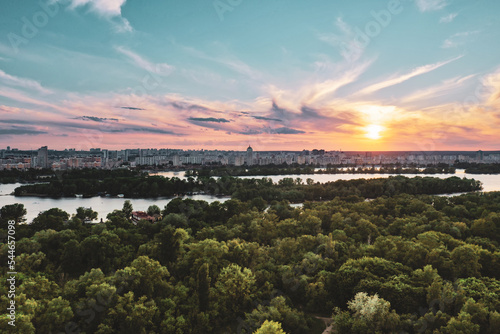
0;171;500;334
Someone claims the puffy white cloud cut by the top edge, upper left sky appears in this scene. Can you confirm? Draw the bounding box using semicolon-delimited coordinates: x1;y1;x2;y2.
63;0;133;33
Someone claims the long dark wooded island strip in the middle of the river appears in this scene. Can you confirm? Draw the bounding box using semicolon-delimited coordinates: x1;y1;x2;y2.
11;169;481;203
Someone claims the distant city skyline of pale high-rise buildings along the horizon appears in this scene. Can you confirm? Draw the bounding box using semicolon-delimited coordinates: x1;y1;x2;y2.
0;146;500;171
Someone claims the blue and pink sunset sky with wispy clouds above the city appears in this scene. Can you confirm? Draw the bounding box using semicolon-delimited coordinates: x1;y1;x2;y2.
0;0;500;151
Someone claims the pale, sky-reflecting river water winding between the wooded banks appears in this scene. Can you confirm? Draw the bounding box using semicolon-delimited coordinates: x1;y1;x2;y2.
0;169;500;222
